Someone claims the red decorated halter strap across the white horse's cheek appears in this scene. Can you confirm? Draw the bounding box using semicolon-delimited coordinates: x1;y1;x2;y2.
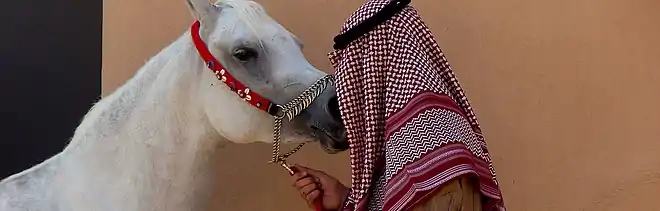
190;21;281;116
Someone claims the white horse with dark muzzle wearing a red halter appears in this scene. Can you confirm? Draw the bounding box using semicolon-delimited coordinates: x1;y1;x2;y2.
0;0;347;211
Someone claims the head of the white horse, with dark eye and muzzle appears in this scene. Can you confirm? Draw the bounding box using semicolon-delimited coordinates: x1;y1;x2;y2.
186;0;348;153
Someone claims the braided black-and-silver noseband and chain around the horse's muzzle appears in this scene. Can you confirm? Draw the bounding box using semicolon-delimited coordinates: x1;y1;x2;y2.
268;75;335;165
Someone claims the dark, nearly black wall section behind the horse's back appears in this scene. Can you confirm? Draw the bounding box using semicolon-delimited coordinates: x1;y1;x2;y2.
0;0;103;178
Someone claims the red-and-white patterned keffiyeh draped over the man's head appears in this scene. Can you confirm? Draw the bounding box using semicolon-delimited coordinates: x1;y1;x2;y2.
329;0;505;211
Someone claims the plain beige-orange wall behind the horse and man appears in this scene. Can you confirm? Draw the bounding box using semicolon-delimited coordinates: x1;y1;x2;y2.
103;0;660;211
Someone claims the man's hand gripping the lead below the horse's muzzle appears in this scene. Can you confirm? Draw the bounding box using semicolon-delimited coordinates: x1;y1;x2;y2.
293;165;349;210
